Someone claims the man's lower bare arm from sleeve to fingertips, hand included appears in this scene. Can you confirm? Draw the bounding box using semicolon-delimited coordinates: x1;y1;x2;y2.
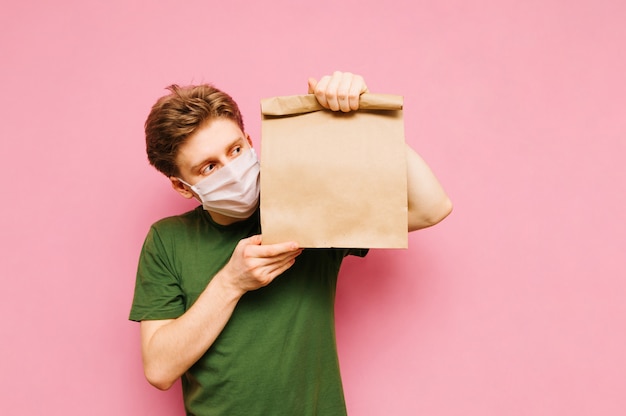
141;235;302;390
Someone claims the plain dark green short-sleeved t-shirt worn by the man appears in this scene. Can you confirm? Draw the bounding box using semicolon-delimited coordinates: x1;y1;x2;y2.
130;207;367;416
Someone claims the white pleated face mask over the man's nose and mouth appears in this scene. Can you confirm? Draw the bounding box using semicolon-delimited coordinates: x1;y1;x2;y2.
179;148;260;218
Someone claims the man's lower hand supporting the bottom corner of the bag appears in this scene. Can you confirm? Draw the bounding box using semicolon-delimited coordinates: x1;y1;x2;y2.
222;235;302;295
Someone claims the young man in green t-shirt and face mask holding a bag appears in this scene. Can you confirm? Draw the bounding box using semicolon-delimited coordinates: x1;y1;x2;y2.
130;72;451;416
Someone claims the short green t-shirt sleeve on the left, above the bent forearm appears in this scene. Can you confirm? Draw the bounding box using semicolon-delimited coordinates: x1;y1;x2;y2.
129;226;185;321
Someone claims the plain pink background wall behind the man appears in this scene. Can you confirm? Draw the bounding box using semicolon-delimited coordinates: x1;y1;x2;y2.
0;0;626;416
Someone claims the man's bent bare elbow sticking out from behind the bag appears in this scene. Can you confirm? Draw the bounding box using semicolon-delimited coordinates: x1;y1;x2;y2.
406;145;452;231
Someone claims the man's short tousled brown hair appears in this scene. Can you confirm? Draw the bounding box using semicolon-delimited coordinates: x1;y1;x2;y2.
145;84;243;177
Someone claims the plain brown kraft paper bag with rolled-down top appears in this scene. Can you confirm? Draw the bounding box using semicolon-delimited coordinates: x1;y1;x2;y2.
261;93;408;248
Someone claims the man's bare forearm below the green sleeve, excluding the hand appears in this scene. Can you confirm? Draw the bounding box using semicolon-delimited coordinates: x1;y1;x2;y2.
141;270;243;390
